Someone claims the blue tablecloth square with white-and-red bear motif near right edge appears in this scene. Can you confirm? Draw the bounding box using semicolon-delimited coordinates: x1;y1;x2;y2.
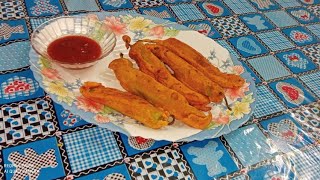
276;50;317;73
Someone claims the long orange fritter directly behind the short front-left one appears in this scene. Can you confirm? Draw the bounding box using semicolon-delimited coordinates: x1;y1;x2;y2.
109;57;212;129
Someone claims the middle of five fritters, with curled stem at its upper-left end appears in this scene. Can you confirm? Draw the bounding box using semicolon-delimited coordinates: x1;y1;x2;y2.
123;36;211;111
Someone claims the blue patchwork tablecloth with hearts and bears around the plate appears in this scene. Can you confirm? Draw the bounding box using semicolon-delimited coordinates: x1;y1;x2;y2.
0;0;320;180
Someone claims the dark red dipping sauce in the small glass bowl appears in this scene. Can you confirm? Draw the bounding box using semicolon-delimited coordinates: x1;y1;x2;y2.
47;36;102;64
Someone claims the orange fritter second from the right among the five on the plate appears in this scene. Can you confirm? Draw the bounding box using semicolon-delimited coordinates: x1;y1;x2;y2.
146;44;224;103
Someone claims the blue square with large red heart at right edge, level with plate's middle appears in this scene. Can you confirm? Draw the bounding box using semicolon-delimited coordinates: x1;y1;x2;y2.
270;78;316;108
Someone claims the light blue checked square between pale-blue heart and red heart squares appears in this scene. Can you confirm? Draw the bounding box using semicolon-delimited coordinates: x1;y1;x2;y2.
257;31;294;51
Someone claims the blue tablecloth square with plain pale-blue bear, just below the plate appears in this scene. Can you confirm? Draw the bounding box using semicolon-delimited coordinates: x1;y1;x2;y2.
180;138;238;179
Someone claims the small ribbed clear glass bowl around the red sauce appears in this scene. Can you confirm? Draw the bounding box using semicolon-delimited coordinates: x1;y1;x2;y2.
31;16;116;69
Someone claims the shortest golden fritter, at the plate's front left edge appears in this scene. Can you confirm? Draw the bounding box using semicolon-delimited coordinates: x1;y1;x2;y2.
80;82;169;129
